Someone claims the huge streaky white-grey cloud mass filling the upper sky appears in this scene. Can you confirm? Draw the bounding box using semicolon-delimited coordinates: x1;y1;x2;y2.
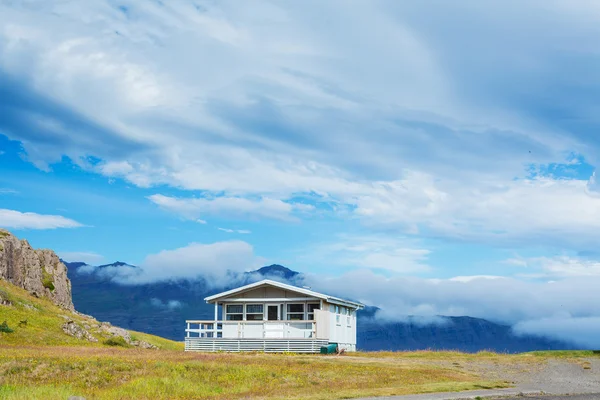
0;0;600;250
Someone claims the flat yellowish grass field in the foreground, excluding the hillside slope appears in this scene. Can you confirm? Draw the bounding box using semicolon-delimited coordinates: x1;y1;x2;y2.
0;346;506;400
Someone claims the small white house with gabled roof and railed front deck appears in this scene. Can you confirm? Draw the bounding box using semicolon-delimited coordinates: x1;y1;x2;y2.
185;280;364;353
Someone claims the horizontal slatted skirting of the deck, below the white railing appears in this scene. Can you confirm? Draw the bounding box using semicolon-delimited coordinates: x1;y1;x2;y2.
185;337;329;353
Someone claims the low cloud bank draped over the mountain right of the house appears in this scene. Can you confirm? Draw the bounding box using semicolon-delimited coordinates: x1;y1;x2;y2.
307;270;600;348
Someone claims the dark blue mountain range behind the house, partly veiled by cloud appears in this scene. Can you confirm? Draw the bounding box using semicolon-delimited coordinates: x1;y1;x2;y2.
65;262;573;353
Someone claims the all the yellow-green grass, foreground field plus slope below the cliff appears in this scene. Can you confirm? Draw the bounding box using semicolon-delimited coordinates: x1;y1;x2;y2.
0;281;597;400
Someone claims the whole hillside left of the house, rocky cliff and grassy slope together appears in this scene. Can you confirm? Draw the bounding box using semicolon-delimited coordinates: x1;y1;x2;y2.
0;230;182;349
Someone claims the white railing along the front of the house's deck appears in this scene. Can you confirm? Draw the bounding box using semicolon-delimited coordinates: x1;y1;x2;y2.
185;320;317;339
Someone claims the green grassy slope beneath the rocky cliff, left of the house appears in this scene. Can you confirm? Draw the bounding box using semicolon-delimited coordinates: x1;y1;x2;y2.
0;280;183;350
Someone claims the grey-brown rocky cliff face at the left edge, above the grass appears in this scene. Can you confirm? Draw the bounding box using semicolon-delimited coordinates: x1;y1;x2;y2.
0;229;74;311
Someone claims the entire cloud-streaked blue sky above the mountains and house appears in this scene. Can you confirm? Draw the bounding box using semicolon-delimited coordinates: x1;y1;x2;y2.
0;0;600;344
